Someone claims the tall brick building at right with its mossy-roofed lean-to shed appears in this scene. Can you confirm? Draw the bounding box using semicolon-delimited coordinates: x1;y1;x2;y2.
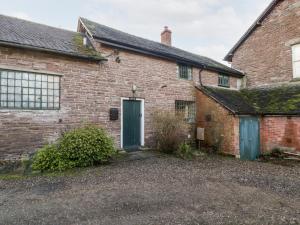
197;0;300;159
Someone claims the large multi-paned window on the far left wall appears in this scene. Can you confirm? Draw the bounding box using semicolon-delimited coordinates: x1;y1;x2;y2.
0;69;60;110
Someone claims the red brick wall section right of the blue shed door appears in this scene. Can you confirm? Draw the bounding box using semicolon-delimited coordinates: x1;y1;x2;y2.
260;116;300;152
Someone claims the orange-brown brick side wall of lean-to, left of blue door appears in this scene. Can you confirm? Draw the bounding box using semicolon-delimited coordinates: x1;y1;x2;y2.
197;91;239;155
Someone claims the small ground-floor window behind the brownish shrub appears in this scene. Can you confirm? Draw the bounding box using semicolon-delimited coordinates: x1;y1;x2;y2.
175;100;196;123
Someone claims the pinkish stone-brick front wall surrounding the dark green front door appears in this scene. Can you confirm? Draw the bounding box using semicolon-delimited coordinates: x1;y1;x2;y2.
0;43;236;158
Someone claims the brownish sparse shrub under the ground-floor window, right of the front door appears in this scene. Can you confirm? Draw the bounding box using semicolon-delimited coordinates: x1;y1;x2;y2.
153;111;188;153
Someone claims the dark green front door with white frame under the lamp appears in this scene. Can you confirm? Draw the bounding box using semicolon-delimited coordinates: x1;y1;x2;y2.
123;100;142;151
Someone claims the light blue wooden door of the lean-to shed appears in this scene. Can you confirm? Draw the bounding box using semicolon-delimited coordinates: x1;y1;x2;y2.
240;117;260;160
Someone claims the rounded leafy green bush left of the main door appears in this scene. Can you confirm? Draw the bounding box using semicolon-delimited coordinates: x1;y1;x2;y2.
32;126;116;171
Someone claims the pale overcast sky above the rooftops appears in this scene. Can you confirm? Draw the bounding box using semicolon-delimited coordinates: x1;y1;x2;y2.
0;0;271;64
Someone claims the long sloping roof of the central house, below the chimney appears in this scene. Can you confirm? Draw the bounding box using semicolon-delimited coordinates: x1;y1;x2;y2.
79;18;243;77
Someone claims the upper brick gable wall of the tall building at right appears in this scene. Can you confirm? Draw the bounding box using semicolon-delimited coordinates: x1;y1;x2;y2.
232;0;300;87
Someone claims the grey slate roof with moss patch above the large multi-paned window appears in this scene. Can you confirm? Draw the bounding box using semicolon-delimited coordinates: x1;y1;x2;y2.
0;15;104;60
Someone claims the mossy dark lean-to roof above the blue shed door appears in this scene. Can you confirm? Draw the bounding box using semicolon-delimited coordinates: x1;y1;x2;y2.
200;83;300;115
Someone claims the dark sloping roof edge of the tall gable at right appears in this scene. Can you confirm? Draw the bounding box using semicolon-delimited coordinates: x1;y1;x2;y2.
224;0;283;62
